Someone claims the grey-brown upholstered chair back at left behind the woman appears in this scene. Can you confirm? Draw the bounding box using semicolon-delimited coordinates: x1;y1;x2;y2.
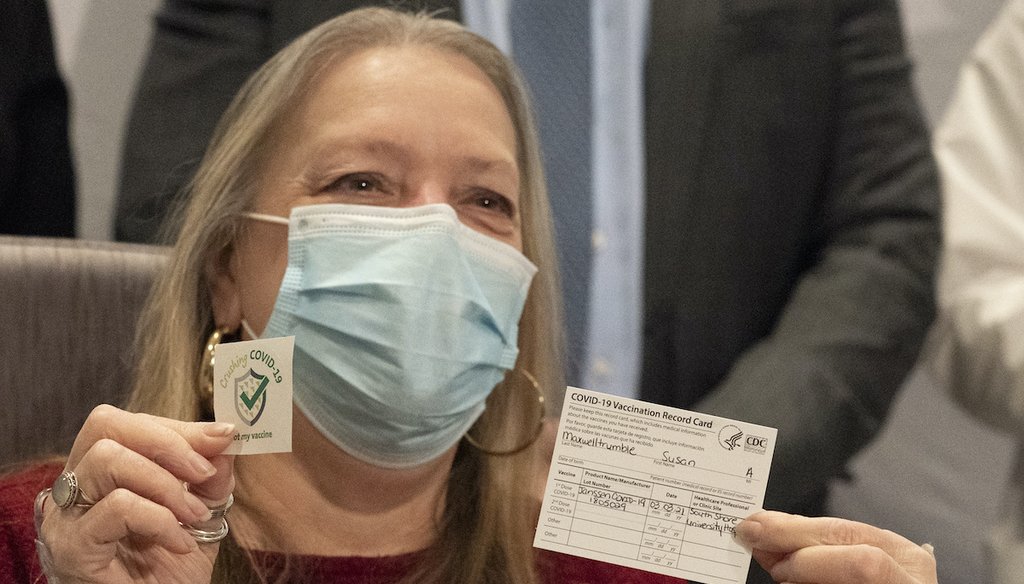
0;237;166;470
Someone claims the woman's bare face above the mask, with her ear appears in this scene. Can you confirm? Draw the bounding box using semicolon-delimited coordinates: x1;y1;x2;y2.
211;47;522;333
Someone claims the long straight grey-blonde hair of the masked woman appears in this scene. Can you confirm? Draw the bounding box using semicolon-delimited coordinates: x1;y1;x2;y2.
129;8;564;584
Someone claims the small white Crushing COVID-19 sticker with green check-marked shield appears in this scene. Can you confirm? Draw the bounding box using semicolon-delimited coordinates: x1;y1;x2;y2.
213;337;295;454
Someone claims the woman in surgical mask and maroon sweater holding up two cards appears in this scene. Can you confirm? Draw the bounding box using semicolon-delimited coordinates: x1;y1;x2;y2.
0;5;934;584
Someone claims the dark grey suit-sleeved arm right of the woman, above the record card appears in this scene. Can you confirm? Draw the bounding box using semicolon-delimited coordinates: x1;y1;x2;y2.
694;0;940;512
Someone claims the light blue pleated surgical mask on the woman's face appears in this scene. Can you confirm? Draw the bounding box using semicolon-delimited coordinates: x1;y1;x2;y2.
247;205;537;468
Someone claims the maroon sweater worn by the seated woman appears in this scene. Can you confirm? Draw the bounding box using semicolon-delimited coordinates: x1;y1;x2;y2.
0;464;685;584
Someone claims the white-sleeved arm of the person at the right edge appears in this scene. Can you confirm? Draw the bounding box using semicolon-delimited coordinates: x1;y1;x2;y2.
936;0;1024;440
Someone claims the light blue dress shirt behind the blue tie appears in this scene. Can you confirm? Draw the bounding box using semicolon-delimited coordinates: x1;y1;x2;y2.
463;0;649;398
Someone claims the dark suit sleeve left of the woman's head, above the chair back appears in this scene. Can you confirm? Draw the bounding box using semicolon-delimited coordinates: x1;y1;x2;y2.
115;0;273;243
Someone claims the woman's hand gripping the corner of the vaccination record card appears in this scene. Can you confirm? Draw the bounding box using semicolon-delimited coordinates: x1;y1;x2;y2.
736;511;938;584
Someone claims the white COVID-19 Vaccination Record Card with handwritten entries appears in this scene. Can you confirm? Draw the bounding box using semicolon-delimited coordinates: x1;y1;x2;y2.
534;387;776;584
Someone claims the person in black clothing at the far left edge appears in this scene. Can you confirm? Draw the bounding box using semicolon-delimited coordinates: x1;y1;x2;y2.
0;0;75;237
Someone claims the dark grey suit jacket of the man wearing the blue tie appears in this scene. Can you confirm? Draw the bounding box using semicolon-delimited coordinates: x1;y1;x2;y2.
112;0;939;577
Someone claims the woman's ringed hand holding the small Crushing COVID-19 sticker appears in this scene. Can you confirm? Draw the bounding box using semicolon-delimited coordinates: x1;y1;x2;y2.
39;406;234;584
